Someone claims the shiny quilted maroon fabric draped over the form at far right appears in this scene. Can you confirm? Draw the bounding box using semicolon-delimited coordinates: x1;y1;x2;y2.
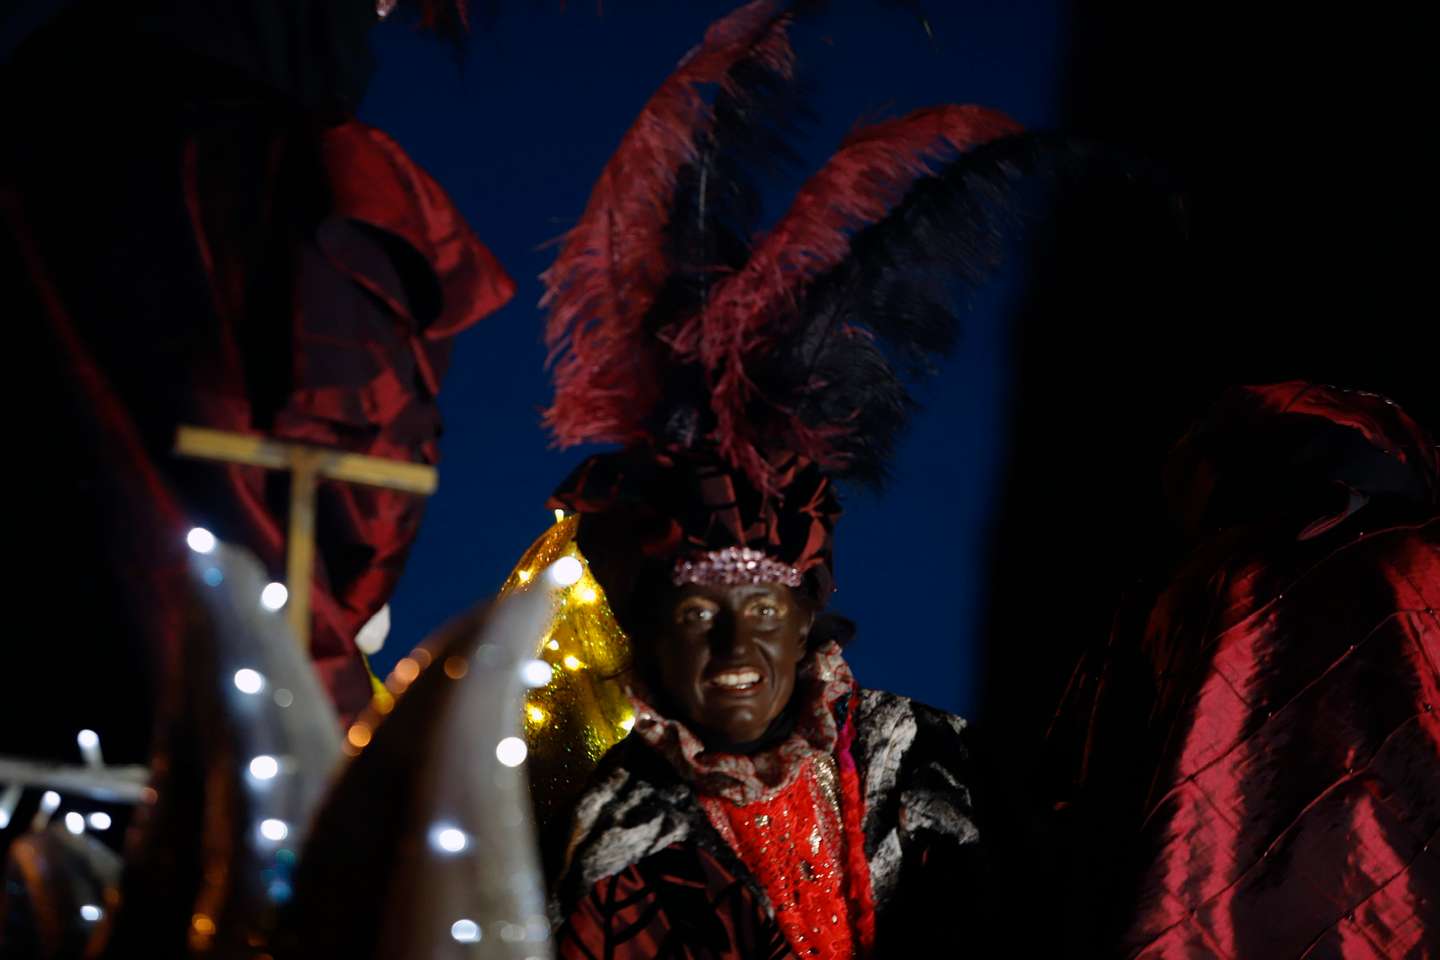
1058;383;1440;957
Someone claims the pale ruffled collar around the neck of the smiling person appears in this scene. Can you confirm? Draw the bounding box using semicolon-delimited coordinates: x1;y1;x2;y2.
631;643;857;806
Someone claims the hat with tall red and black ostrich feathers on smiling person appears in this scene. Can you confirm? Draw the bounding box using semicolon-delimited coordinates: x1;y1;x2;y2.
541;0;1031;616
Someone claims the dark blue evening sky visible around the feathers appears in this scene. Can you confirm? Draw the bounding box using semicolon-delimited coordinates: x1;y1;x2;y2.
360;0;1064;712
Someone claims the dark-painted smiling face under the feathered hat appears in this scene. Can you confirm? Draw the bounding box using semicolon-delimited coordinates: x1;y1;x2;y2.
654;583;814;744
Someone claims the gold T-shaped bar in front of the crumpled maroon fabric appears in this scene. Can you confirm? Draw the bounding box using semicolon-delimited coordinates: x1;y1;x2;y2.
176;426;436;652
